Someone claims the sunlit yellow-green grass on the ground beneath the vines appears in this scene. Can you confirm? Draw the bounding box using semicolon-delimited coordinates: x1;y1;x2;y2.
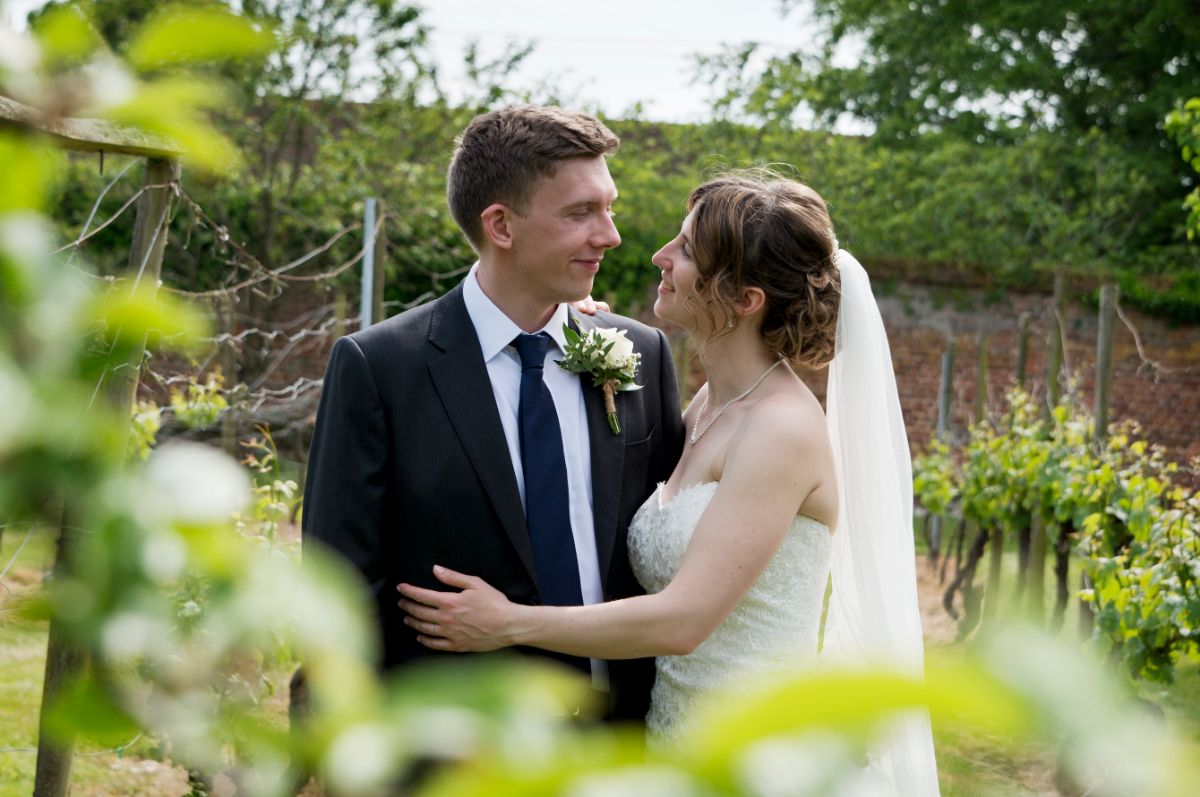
0;529;1200;797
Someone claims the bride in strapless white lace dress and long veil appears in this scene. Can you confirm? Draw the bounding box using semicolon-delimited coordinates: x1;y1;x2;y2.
400;174;937;797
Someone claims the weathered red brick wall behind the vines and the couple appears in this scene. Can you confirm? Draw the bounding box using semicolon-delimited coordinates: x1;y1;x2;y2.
672;284;1200;462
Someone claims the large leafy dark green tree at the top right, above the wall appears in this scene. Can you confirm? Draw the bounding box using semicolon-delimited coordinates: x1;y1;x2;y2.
700;0;1200;289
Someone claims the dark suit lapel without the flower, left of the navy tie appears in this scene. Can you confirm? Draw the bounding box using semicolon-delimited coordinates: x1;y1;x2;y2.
430;284;538;583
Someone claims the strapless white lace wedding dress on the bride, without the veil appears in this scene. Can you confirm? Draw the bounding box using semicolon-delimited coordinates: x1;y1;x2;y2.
629;481;833;745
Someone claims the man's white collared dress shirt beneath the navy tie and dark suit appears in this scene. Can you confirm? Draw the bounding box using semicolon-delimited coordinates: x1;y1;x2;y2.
462;263;605;688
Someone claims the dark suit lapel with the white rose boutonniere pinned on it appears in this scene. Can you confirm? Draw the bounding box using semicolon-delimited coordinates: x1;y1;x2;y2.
571;311;625;585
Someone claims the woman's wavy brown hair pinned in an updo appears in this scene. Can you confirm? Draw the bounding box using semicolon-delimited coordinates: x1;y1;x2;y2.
688;172;841;368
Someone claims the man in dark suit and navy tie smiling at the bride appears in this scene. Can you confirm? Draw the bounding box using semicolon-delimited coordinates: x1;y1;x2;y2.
304;106;684;720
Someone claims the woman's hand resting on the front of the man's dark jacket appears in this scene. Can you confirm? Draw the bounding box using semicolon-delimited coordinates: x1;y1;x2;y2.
396;565;517;653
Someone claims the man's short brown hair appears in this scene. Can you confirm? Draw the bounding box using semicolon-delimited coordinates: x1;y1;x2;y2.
446;106;620;251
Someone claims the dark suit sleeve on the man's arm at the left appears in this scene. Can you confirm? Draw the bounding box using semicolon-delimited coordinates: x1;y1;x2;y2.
302;337;390;601
